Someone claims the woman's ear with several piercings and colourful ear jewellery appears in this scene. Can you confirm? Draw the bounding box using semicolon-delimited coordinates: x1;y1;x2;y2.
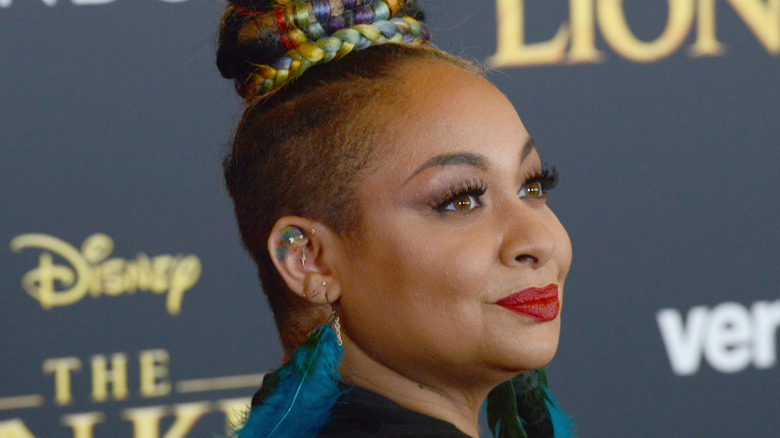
268;216;341;304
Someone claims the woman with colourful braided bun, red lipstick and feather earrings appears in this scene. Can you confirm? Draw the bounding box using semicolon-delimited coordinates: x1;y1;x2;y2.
217;0;571;437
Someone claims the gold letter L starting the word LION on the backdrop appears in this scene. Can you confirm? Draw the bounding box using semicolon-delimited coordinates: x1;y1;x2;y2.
487;0;568;67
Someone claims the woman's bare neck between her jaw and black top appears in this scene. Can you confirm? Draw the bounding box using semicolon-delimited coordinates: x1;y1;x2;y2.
341;334;492;438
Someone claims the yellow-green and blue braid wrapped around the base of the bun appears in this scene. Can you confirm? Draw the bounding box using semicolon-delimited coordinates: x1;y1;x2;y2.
239;16;428;100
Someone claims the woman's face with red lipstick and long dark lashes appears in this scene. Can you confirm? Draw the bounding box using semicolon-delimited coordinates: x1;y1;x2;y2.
335;61;571;390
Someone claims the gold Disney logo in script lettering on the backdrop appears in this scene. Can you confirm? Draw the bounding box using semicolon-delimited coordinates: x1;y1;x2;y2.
10;233;201;315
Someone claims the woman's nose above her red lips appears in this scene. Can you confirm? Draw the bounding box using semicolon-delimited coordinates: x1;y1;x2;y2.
499;201;556;268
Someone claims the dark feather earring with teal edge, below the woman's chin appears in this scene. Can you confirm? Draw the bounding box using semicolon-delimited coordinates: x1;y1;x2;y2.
487;369;574;438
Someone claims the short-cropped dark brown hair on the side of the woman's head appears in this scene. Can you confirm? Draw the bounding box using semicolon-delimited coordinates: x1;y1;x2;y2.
218;1;476;352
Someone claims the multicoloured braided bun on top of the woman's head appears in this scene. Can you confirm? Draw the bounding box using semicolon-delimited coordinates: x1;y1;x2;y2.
217;0;429;100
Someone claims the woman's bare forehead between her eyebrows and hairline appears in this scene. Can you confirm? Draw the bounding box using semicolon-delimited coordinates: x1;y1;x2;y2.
379;61;533;178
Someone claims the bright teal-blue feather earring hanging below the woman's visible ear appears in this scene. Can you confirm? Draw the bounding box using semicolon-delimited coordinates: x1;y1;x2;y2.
233;320;343;438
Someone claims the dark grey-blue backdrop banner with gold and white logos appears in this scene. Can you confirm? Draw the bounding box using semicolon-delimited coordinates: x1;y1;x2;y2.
0;0;780;438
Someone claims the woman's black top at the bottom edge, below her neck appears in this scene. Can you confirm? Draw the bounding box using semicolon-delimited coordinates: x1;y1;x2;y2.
317;386;469;438
